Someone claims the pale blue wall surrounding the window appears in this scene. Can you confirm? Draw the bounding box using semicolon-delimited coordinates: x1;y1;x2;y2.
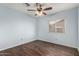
38;8;78;48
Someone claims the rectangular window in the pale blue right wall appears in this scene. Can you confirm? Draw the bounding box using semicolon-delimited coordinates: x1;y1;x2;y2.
49;19;64;33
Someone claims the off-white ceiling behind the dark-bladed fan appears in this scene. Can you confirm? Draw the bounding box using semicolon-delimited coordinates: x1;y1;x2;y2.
0;3;79;16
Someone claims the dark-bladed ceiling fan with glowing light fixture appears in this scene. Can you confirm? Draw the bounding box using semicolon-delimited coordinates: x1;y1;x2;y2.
25;3;52;16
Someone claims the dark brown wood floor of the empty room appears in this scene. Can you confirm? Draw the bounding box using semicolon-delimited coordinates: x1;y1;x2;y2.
0;40;78;56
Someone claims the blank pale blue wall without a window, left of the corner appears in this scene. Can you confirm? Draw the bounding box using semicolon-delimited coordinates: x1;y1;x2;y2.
0;5;36;50
